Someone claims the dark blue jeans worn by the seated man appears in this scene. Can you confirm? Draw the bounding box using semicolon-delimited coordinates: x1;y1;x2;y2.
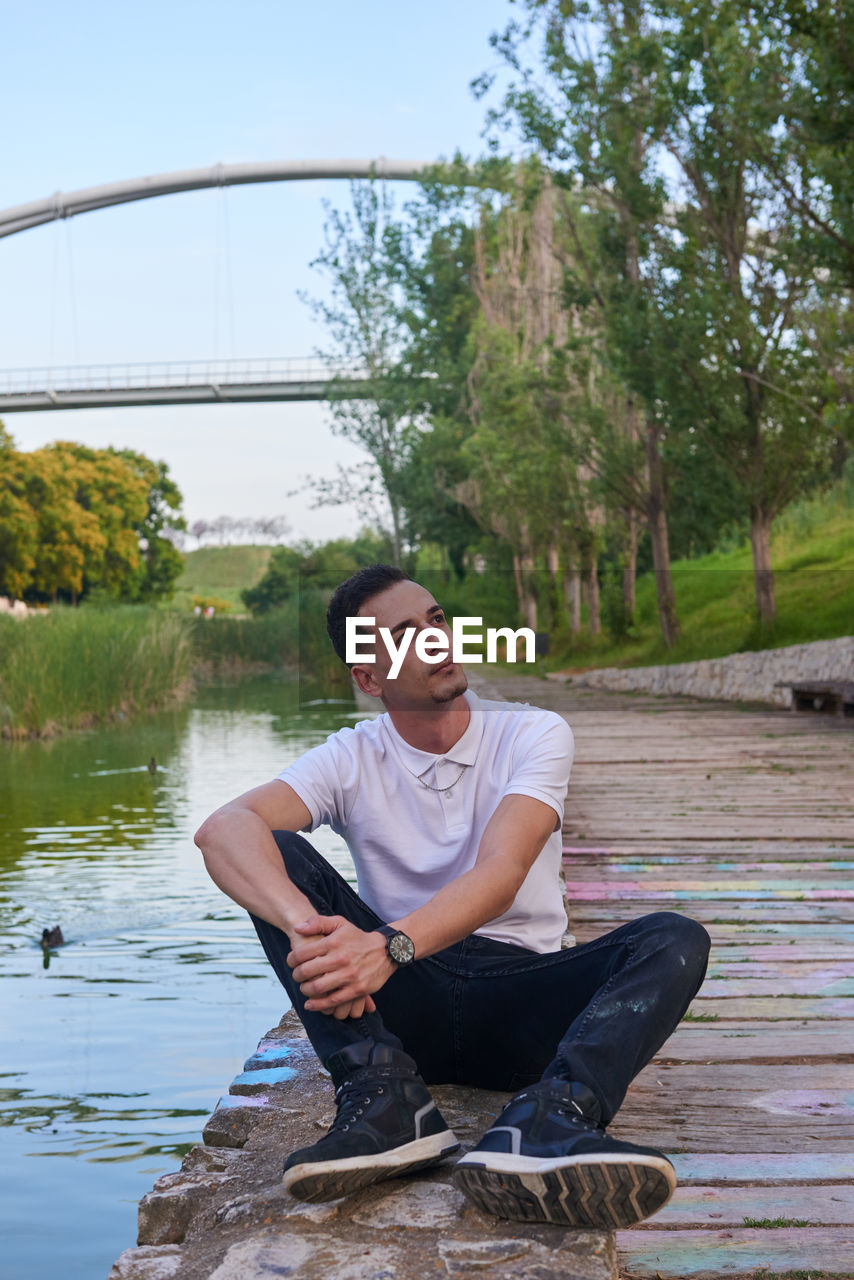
252;831;709;1124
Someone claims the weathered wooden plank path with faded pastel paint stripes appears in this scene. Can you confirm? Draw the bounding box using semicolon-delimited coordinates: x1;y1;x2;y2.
483;673;854;1280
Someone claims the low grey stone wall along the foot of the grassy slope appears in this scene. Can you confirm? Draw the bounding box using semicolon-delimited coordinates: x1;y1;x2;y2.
571;636;854;707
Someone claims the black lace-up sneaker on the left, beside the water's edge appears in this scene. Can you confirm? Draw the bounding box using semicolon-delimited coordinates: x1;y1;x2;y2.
283;1041;460;1201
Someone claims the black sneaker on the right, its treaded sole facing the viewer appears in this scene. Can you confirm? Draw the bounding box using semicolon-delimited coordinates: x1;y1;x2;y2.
453;1079;676;1231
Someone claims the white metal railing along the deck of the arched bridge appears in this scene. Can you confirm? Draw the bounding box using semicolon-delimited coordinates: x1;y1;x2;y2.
0;356;366;396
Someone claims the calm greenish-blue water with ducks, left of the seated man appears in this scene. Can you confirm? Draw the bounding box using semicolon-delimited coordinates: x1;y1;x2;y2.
0;678;362;1280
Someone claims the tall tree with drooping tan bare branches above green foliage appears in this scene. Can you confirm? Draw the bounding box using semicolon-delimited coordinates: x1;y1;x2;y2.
463;164;602;630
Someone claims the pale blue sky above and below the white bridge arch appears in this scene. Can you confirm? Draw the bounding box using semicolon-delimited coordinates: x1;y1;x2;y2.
0;0;513;540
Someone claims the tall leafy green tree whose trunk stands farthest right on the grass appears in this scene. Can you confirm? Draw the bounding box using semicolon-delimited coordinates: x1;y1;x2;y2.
657;0;830;623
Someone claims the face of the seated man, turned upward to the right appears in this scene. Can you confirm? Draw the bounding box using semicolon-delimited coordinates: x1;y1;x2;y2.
353;581;467;710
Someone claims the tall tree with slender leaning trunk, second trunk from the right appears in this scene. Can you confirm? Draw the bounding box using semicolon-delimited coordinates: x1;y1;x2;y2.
475;0;680;645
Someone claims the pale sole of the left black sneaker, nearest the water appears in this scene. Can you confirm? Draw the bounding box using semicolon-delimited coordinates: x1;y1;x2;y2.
282;1129;460;1202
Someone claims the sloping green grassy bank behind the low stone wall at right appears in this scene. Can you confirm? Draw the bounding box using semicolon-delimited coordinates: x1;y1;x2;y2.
548;492;854;671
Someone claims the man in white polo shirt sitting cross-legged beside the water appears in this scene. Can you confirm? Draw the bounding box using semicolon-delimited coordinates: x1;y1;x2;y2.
196;564;708;1229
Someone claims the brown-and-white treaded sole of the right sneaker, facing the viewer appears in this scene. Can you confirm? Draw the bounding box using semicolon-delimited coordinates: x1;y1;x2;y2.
453;1152;676;1230
